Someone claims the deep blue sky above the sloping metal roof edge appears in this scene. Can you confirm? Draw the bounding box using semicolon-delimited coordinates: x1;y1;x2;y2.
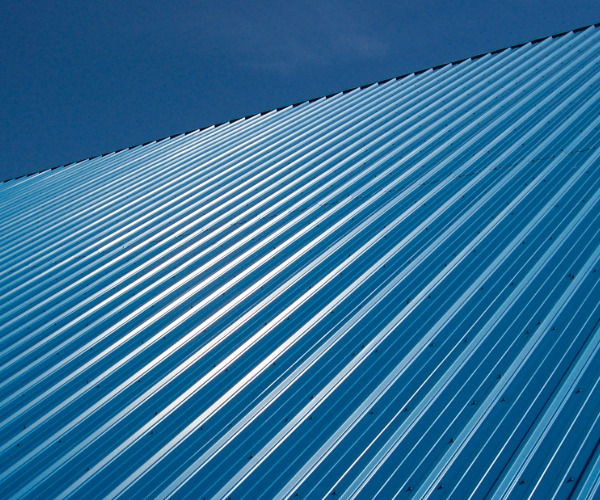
0;0;600;180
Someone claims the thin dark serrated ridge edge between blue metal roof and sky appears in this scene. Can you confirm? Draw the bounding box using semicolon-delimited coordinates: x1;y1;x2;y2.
2;23;600;183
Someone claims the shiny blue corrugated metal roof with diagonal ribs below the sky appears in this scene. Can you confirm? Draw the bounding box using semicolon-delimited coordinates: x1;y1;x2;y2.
0;21;600;500
